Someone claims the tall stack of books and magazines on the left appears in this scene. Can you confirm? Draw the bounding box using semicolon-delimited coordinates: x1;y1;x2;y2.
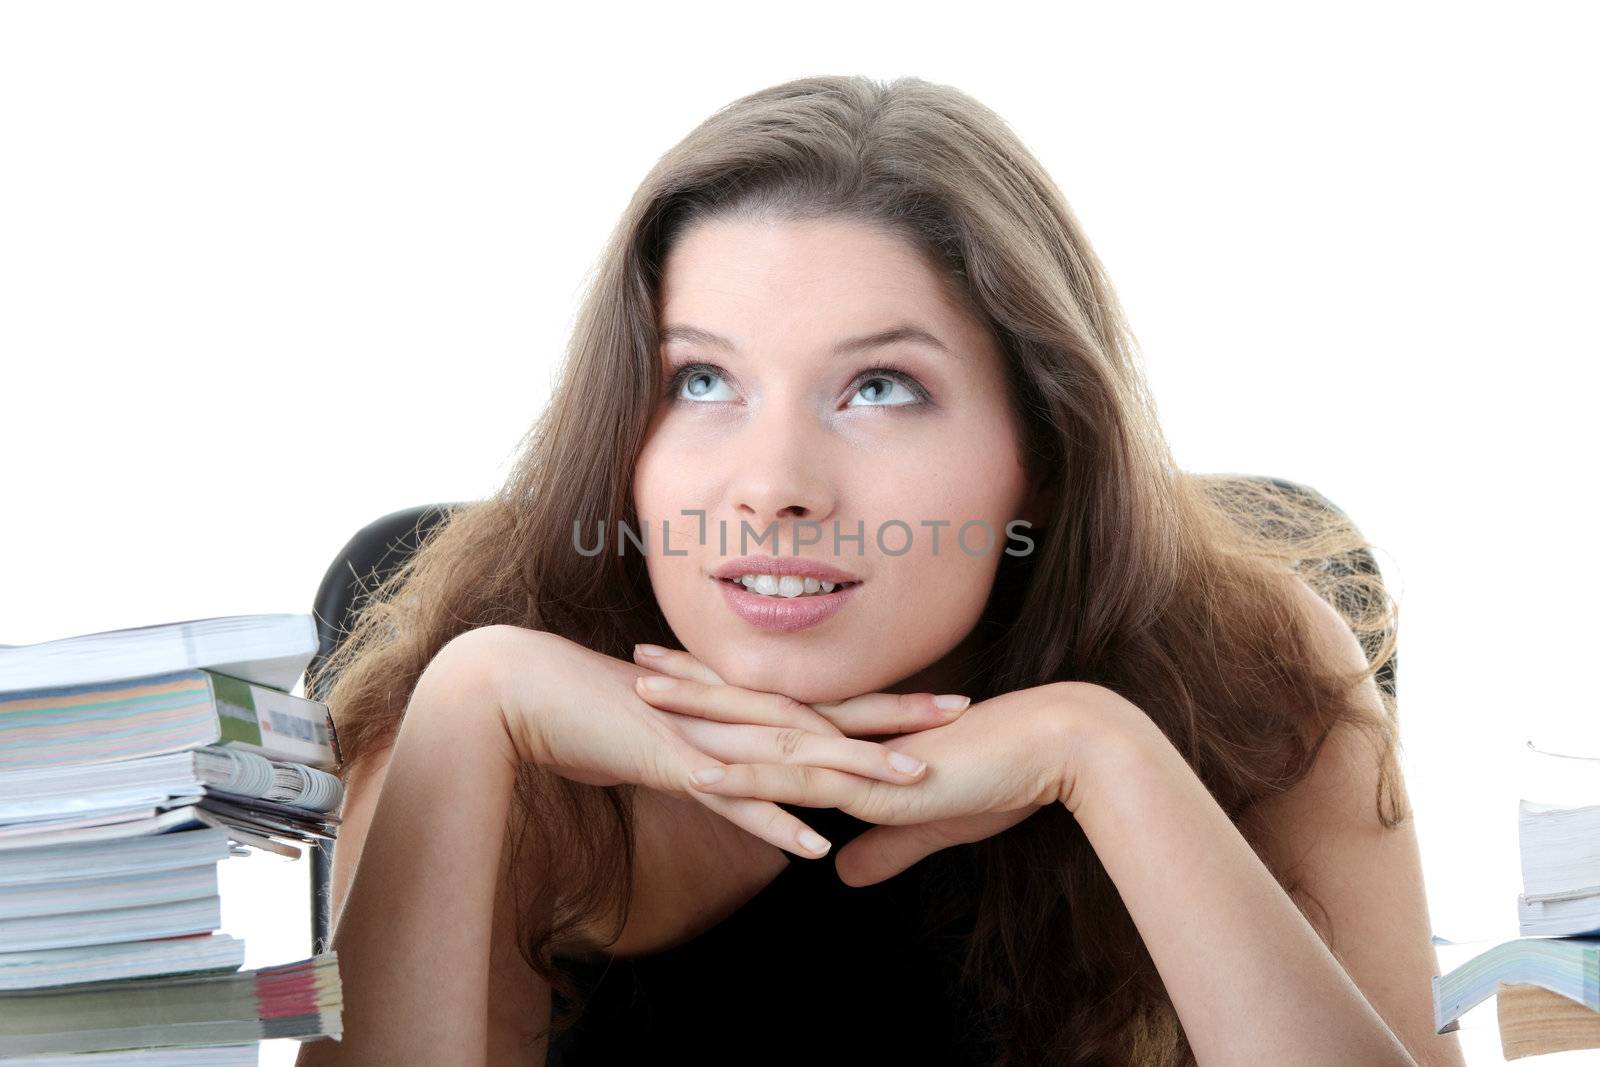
0;614;342;1065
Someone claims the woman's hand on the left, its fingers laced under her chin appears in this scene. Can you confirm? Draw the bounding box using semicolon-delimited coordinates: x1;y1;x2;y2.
451;625;960;859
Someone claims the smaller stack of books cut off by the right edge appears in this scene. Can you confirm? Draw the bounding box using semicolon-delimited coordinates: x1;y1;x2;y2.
1434;745;1600;1059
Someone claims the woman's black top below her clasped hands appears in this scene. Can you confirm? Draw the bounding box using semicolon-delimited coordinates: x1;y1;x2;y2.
546;805;984;1067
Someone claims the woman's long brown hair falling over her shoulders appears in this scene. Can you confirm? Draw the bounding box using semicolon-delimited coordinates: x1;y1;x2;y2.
308;77;1406;1064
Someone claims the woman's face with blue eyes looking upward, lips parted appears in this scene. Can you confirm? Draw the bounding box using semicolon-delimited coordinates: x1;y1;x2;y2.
624;221;1027;702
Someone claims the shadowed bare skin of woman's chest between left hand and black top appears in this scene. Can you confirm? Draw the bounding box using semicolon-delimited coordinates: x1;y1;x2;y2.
563;787;789;958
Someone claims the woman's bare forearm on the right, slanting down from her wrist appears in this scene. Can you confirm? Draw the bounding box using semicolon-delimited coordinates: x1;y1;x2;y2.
1074;723;1414;1067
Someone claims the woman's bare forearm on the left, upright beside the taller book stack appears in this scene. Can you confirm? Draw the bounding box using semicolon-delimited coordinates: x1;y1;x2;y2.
298;648;549;1067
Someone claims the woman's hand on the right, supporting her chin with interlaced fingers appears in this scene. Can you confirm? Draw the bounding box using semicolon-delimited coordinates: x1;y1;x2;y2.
640;680;1120;886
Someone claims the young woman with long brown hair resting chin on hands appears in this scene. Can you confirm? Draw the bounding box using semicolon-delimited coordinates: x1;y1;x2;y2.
291;77;1462;1065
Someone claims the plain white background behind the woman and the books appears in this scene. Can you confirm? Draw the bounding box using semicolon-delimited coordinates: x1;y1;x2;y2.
0;3;1600;1064
